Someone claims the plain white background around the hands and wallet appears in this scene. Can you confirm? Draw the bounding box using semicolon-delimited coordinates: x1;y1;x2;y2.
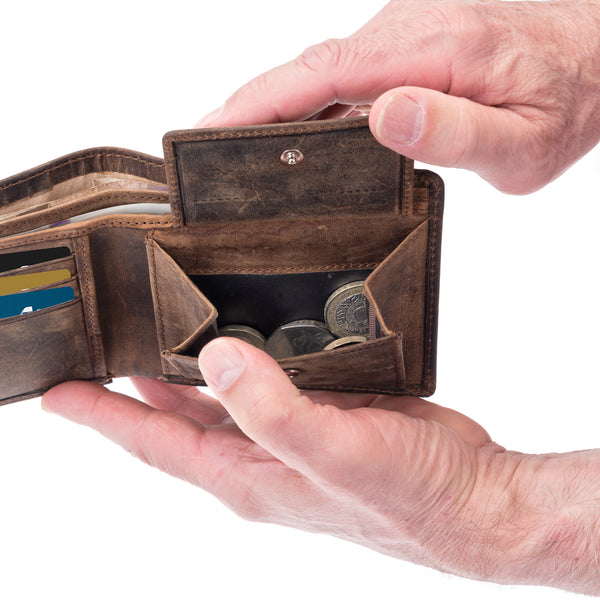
0;0;600;600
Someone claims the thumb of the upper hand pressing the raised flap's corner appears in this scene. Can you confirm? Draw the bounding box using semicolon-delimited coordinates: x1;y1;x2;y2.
370;87;548;194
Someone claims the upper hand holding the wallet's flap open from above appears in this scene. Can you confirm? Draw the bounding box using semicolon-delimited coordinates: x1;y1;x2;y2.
199;0;600;194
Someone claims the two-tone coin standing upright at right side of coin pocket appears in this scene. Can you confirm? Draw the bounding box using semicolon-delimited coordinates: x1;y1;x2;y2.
325;281;369;337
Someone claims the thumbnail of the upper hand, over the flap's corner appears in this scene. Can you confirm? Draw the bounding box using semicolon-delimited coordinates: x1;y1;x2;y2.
375;92;423;144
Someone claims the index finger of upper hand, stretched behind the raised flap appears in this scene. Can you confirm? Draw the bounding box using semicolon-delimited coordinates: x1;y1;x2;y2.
197;36;451;127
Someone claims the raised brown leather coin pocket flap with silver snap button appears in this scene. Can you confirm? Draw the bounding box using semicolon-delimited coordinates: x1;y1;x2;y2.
163;117;413;225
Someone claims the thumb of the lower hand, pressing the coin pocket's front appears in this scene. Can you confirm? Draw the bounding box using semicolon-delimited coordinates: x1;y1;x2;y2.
199;338;345;473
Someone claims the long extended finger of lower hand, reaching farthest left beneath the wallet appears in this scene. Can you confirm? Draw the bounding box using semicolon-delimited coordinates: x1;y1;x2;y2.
42;382;328;524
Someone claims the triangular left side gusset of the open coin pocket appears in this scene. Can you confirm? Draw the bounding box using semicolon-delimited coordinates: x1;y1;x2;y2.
147;240;217;369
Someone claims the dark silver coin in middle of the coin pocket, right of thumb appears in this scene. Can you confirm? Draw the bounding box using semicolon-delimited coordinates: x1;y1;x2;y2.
265;320;335;359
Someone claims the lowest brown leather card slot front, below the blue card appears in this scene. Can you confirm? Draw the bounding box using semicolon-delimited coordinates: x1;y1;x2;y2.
0;298;94;404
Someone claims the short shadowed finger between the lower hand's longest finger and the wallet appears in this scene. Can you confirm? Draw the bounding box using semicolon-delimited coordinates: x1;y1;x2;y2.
131;377;231;425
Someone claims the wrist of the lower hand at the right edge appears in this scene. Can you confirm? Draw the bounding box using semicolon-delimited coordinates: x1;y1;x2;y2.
452;451;600;594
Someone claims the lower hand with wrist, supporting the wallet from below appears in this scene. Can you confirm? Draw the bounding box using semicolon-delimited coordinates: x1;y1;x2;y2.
43;338;600;592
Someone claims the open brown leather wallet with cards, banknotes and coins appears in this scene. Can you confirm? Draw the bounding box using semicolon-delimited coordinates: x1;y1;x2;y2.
0;118;443;404
